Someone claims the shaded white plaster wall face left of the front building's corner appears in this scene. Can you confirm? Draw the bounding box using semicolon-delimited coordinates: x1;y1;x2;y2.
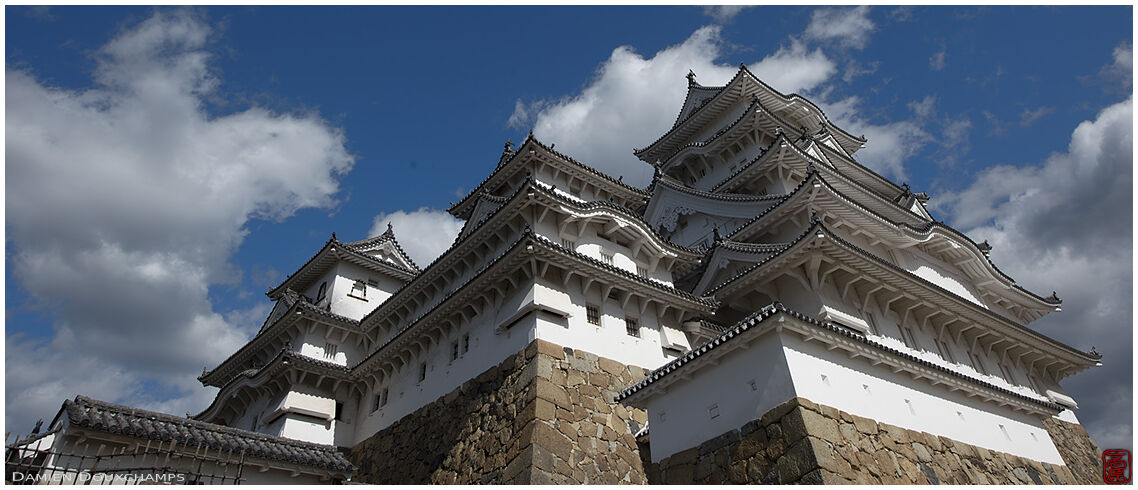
637;329;794;463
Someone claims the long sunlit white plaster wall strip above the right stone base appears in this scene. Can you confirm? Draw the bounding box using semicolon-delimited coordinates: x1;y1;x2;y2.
782;334;1063;464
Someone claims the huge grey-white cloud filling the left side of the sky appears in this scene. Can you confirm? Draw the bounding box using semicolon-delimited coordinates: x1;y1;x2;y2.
5;10;354;431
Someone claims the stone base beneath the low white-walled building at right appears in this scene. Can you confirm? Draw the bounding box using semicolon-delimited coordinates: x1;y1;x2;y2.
648;398;1102;484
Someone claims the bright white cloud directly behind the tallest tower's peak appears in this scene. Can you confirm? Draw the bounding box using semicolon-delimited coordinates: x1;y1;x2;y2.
510;26;836;185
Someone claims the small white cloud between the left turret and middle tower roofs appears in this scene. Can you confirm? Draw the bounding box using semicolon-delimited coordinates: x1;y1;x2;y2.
368;207;463;267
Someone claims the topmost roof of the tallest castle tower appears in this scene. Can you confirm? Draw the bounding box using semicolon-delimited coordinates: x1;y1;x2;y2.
634;64;866;165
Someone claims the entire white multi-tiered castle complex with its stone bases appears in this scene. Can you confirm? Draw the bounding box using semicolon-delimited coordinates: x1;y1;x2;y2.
9;66;1102;484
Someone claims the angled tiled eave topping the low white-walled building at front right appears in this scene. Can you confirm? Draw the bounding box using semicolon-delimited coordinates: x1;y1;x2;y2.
615;302;1063;412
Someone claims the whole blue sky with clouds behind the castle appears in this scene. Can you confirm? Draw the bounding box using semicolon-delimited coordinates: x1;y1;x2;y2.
6;7;1132;447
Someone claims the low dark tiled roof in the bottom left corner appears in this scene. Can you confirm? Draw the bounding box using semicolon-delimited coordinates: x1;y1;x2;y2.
64;396;355;473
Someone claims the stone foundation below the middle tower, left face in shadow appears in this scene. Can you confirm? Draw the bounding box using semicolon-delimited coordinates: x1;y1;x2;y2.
348;340;648;484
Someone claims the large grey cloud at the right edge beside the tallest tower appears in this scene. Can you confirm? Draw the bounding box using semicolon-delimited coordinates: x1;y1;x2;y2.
934;99;1133;448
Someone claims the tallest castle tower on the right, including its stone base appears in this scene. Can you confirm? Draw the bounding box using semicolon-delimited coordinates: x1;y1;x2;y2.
618;66;1100;483
